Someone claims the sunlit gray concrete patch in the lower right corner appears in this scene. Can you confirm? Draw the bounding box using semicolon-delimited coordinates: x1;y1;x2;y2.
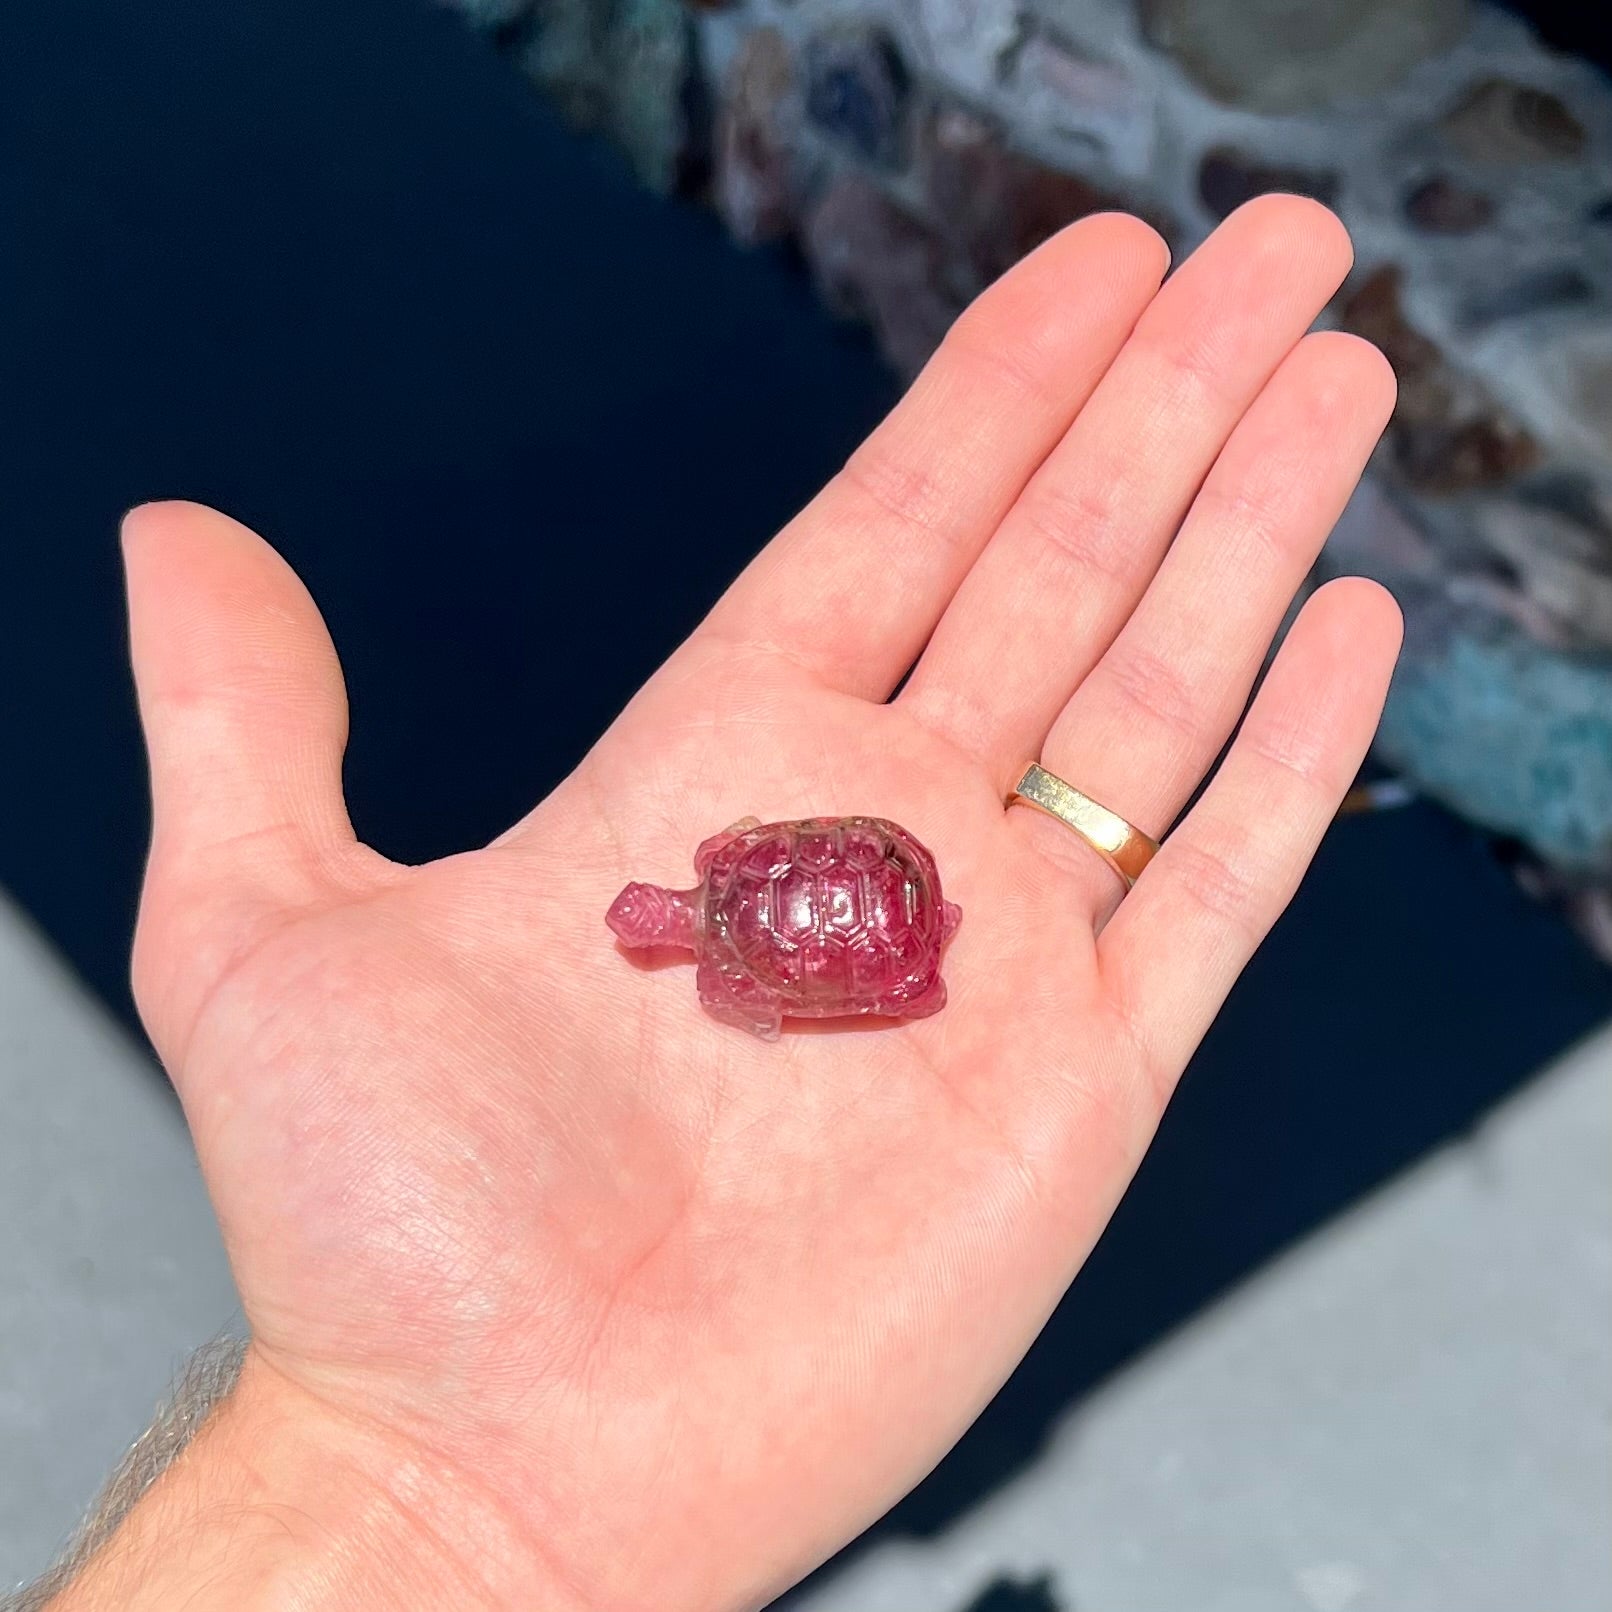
803;1033;1612;1612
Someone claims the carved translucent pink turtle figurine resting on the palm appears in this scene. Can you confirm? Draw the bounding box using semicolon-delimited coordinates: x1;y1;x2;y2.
605;817;962;1041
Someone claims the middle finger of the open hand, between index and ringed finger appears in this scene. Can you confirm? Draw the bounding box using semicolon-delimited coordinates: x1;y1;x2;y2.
899;197;1352;782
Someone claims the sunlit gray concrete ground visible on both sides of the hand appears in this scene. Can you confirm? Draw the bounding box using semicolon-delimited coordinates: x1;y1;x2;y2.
0;904;1612;1612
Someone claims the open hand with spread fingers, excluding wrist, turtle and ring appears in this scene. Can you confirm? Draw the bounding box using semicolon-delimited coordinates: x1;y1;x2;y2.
126;198;1398;1609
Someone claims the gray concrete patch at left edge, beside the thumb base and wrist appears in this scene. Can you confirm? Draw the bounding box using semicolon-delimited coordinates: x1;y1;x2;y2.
0;896;237;1586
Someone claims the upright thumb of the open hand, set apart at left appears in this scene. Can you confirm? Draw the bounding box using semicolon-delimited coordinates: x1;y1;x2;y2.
123;503;355;1049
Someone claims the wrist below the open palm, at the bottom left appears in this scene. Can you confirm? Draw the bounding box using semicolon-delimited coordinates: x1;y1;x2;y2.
50;1349;584;1612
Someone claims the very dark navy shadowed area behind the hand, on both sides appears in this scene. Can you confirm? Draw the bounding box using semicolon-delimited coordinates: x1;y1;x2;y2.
0;0;1612;1586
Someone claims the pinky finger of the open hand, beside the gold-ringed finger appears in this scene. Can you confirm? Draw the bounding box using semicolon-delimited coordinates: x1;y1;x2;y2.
1099;577;1401;1093
